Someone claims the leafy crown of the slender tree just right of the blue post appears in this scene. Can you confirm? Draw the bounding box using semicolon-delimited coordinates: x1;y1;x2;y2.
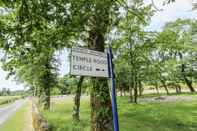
111;0;154;98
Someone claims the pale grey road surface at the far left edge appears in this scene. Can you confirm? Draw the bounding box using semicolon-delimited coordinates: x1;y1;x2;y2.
0;100;25;125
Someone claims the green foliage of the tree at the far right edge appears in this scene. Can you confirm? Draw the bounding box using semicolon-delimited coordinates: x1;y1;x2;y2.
155;19;197;86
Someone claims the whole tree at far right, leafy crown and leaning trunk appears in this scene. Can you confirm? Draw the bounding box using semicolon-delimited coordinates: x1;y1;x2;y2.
156;19;196;92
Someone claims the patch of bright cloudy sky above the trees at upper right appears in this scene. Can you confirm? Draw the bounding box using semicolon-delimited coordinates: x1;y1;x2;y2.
146;0;197;31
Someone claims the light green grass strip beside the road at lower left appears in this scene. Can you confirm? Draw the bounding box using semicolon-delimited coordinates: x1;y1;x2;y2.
0;103;28;131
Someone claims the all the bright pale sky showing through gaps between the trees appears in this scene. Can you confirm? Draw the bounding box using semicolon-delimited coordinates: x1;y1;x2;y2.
0;0;197;90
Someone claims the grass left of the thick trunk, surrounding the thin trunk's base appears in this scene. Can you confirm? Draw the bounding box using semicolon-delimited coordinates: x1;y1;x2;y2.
43;100;90;131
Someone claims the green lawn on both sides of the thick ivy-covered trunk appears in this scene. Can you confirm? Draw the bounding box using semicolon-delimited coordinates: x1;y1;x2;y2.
43;97;197;131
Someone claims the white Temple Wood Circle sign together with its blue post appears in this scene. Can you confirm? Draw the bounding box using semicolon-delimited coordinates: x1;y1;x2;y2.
70;47;119;131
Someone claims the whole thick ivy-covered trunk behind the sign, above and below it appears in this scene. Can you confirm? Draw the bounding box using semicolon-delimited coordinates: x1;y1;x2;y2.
88;0;113;131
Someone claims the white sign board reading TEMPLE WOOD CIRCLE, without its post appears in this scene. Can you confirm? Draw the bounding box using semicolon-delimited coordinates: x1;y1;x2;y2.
70;47;108;77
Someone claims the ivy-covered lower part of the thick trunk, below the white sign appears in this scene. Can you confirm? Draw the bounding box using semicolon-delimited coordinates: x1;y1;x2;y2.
90;78;113;131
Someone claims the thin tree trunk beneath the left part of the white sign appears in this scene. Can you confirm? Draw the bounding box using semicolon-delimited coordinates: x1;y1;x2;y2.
73;76;84;121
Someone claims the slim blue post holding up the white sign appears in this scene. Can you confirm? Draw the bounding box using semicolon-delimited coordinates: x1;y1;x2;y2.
108;48;119;131
